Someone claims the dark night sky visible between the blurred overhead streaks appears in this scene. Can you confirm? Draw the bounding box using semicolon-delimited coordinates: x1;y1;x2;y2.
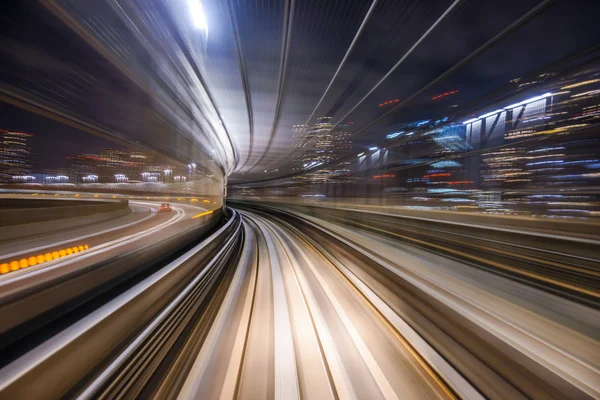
0;0;600;175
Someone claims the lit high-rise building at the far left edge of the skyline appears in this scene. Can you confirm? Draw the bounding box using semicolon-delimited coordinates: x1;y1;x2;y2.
0;129;33;182
